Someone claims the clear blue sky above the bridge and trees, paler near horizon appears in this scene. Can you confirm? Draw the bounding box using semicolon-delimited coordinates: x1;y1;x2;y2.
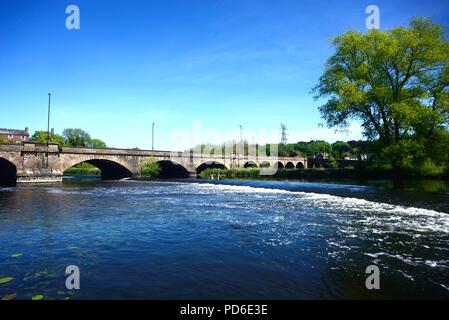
0;0;449;150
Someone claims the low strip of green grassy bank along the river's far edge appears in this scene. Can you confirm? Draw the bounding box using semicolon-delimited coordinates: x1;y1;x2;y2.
199;168;449;180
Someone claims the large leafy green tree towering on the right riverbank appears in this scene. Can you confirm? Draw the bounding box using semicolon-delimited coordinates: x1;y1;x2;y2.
313;18;449;168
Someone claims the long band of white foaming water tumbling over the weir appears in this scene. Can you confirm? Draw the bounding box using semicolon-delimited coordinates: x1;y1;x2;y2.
43;182;449;233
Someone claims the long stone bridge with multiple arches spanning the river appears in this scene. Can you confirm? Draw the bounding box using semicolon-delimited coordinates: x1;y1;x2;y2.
0;142;307;182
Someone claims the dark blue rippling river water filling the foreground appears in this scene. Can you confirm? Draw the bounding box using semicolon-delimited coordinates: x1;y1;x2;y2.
0;180;449;299
